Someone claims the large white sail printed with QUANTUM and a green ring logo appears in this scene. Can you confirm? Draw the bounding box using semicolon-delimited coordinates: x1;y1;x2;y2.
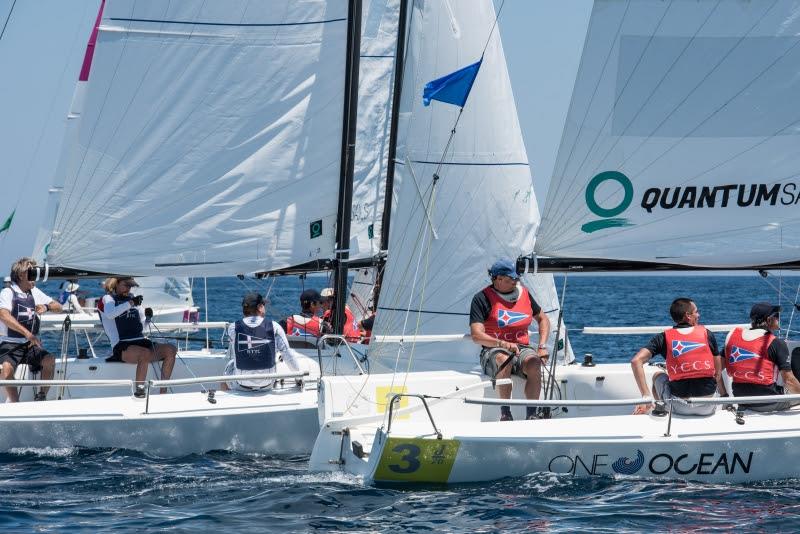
536;0;800;267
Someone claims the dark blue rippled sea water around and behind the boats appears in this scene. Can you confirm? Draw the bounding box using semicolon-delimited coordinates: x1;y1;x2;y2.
0;275;800;532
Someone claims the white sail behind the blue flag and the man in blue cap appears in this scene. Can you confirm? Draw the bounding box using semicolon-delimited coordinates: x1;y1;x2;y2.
370;1;558;371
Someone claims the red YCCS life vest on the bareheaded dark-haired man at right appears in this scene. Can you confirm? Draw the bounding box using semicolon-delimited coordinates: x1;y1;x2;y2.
664;324;714;381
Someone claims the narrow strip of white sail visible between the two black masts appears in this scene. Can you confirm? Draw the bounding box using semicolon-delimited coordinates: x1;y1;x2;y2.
350;0;400;259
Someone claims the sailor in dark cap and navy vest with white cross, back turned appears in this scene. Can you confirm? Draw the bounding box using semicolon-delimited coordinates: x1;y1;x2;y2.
222;293;309;390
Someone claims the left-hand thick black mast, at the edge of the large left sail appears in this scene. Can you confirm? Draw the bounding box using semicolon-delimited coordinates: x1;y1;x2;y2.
333;0;361;333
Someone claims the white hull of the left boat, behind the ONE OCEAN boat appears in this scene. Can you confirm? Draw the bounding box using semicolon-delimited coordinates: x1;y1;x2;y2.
0;384;319;457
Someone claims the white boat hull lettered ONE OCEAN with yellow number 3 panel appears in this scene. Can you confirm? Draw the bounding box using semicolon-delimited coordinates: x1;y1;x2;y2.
310;364;800;483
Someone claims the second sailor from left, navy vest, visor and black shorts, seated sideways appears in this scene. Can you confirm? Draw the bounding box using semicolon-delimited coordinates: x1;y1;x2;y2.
98;276;178;398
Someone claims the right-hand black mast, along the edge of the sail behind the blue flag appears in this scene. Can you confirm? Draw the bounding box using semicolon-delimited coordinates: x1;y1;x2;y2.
372;0;408;310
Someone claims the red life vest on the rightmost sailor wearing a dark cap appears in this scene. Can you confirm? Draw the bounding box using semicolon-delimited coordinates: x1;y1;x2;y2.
725;328;777;386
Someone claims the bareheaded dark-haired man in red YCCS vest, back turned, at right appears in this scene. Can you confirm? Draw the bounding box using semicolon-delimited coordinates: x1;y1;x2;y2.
631;297;725;415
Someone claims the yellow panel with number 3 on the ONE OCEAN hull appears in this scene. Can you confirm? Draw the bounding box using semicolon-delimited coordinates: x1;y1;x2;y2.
375;438;460;482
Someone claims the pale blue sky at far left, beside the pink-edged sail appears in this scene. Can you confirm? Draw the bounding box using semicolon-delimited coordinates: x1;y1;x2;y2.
0;0;100;272
